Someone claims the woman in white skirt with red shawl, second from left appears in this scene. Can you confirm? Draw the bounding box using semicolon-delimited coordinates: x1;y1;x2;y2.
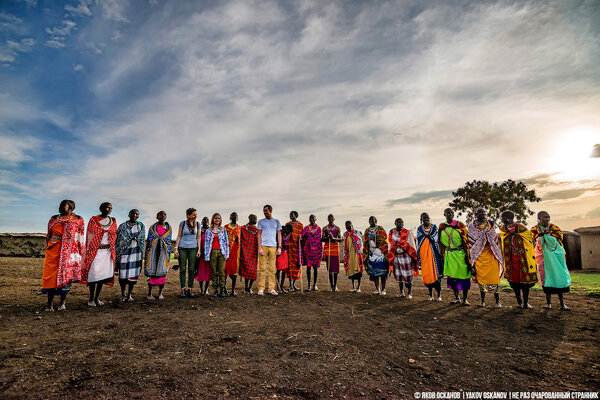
80;203;117;307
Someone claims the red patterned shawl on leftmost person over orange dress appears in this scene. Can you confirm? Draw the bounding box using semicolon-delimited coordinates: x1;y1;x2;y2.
46;215;85;288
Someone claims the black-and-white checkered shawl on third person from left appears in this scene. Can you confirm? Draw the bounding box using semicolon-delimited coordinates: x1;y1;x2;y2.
115;222;146;279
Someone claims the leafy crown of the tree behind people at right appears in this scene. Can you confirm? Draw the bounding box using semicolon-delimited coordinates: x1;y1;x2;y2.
448;179;541;224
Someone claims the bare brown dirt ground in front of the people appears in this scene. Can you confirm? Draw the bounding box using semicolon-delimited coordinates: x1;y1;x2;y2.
0;258;600;399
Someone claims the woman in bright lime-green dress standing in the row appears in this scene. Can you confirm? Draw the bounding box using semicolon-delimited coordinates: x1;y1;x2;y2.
440;208;471;306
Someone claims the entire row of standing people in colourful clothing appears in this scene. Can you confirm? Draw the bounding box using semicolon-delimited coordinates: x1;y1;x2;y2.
42;200;570;311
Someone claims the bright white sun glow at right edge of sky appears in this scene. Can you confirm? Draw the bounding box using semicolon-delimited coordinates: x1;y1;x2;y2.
551;126;600;180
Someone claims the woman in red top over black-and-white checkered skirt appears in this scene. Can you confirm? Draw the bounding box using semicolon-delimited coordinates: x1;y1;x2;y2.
387;218;419;300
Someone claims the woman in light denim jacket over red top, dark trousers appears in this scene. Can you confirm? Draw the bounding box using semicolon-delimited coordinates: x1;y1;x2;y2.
204;213;229;297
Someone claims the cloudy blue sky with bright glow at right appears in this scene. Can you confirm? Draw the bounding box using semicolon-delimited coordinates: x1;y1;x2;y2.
0;0;600;232
